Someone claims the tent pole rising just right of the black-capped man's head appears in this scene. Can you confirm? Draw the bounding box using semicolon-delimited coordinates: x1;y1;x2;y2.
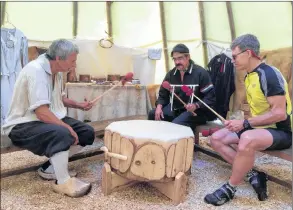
198;1;208;67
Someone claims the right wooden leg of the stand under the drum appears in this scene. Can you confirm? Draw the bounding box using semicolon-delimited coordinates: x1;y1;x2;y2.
150;172;187;205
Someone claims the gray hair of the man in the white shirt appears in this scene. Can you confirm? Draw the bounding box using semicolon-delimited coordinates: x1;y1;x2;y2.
47;39;79;60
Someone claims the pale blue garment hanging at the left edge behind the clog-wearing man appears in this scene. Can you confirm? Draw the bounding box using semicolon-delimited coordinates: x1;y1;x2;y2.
1;28;28;126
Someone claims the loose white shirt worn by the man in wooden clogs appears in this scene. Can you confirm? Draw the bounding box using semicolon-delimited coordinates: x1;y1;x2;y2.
2;55;66;135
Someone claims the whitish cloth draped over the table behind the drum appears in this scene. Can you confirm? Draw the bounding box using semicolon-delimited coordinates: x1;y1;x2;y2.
66;83;151;122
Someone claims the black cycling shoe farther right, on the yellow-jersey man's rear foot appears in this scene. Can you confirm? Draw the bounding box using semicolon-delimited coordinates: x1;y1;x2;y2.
247;170;268;201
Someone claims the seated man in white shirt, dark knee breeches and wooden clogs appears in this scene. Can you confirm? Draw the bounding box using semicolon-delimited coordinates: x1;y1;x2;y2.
2;39;95;197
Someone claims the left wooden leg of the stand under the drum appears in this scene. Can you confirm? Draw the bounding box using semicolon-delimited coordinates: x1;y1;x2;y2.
102;162;137;195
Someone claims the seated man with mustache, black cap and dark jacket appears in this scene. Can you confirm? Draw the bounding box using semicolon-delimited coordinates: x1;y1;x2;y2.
148;44;216;130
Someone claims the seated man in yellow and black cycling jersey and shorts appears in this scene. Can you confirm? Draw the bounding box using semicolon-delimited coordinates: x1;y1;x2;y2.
204;34;292;206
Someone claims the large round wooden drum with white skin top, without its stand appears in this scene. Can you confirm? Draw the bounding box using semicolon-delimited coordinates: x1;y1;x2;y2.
104;120;194;182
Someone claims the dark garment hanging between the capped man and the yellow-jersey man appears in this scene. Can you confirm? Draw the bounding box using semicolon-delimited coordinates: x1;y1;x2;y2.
208;53;235;118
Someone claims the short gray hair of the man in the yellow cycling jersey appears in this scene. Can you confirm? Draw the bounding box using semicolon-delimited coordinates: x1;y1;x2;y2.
230;34;260;55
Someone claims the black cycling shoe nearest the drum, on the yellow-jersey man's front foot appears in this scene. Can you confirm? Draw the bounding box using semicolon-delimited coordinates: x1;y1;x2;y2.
204;183;236;206
